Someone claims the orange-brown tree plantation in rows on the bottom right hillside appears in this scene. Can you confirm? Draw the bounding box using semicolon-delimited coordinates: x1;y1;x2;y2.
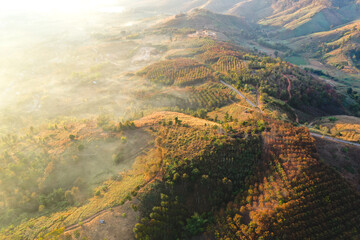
215;124;360;239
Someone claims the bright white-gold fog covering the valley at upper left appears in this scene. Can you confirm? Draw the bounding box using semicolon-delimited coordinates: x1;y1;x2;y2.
0;0;170;133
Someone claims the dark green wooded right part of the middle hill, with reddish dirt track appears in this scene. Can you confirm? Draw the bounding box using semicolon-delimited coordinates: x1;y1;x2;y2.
224;57;344;115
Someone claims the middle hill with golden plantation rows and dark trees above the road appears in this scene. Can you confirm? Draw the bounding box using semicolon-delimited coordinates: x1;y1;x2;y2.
139;41;360;117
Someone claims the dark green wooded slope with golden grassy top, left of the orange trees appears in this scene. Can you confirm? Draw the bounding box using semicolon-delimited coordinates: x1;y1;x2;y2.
134;119;261;239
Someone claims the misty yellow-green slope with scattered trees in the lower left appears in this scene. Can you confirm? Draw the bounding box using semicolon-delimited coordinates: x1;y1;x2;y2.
0;116;153;239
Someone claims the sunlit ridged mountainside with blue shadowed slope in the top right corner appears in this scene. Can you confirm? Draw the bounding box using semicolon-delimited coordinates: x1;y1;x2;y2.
259;0;360;37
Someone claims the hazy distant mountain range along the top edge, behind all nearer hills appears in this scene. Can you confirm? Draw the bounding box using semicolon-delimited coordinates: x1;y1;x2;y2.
136;0;360;38
